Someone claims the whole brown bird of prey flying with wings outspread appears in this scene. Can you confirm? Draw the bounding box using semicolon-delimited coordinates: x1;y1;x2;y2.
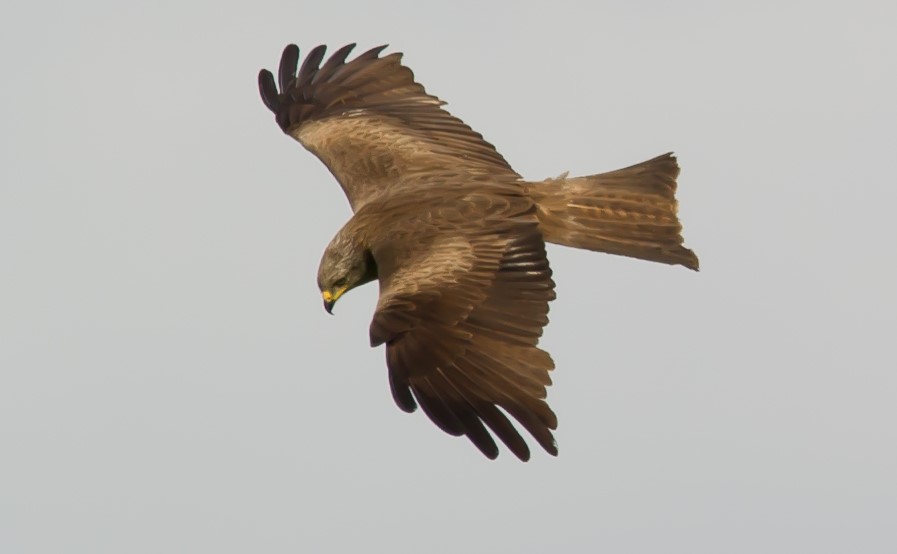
259;44;698;461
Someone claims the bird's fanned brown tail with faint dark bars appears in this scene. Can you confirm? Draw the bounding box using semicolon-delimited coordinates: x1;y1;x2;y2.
527;153;698;270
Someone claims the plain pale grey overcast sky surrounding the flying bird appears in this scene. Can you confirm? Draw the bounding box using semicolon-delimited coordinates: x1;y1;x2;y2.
0;0;897;554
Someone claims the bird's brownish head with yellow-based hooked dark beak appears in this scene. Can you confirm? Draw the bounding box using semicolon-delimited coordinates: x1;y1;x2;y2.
318;233;377;314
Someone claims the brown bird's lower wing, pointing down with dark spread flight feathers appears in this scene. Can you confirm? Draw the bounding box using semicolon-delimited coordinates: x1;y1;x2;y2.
371;190;557;460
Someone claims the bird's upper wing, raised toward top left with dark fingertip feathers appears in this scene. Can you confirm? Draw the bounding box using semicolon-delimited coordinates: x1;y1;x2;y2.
259;44;519;211
